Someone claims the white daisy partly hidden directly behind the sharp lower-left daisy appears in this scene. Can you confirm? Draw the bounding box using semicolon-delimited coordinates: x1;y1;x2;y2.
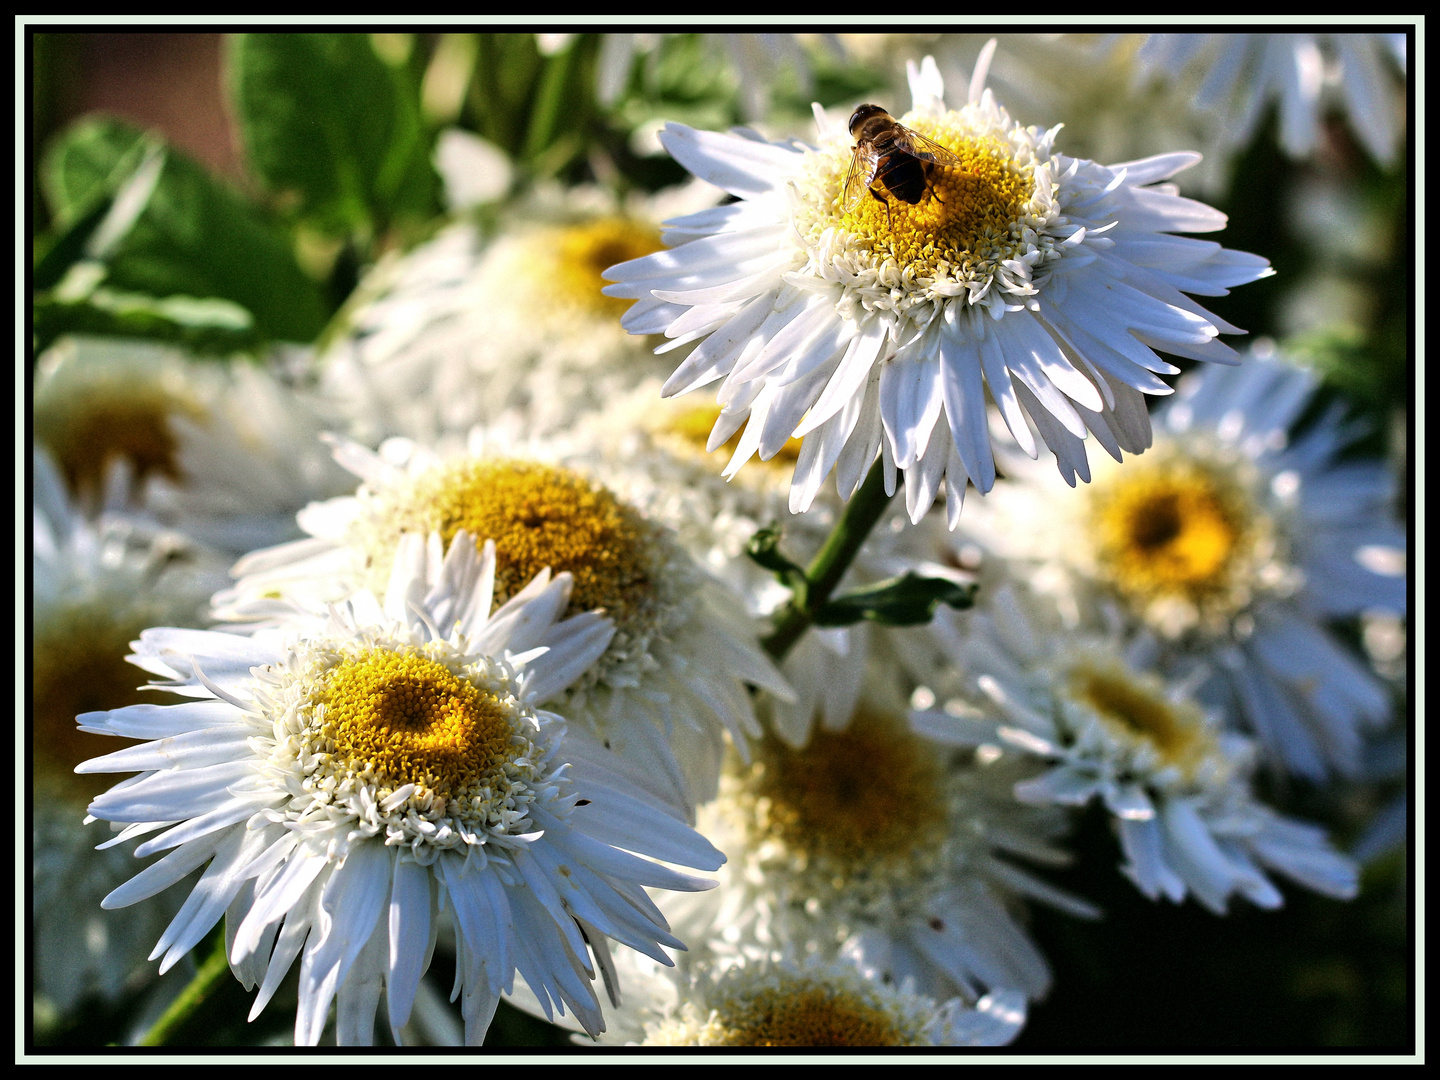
216;429;789;818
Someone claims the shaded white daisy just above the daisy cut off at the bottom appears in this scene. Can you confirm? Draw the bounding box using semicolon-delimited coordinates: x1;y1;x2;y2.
665;683;1093;1001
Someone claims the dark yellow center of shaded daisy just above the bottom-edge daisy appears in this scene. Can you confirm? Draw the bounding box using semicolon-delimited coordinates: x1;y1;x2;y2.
747;711;946;878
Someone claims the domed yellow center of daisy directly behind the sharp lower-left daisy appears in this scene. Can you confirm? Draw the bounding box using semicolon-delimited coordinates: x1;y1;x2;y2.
372;458;654;624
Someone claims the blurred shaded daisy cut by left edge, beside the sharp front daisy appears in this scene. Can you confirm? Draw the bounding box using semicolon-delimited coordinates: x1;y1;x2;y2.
27;451;225;1014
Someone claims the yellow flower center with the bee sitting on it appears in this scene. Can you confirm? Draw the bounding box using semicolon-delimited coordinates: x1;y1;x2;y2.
835;114;1032;279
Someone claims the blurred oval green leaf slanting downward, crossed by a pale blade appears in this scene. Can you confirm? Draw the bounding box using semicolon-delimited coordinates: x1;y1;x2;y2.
42;118;327;341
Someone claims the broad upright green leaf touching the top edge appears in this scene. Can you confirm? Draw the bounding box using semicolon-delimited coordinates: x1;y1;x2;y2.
229;33;439;235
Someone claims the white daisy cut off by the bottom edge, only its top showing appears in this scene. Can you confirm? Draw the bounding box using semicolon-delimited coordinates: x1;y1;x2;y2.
600;956;1025;1047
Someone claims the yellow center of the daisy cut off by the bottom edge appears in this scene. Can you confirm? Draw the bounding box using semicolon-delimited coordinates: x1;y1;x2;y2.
671;979;913;1047
